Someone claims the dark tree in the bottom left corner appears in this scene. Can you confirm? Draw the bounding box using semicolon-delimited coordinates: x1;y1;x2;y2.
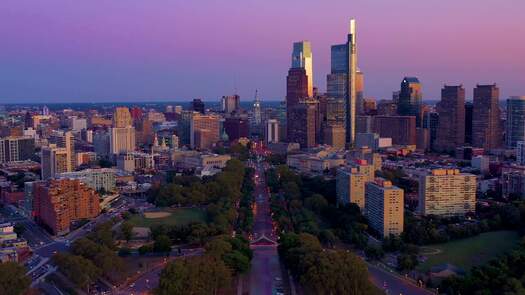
0;262;31;295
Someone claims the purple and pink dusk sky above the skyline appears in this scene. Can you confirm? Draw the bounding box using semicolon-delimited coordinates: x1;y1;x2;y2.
0;0;525;103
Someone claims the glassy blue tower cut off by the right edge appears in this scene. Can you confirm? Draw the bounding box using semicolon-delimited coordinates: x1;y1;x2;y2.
505;96;525;148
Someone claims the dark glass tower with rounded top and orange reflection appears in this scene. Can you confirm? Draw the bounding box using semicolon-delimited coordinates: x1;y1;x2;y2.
397;77;423;127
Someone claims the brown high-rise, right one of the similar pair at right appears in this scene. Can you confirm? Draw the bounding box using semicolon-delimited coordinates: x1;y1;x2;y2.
472;84;503;150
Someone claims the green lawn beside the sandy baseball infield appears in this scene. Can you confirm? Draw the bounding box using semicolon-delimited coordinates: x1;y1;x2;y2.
130;208;206;227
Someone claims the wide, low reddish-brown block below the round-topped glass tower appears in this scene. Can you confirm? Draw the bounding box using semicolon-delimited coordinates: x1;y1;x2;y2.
373;116;417;145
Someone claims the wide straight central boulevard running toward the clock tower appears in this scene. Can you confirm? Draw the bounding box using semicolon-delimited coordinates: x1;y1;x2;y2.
245;164;283;295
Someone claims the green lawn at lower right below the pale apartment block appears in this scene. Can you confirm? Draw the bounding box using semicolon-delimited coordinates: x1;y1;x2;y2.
418;231;519;271
